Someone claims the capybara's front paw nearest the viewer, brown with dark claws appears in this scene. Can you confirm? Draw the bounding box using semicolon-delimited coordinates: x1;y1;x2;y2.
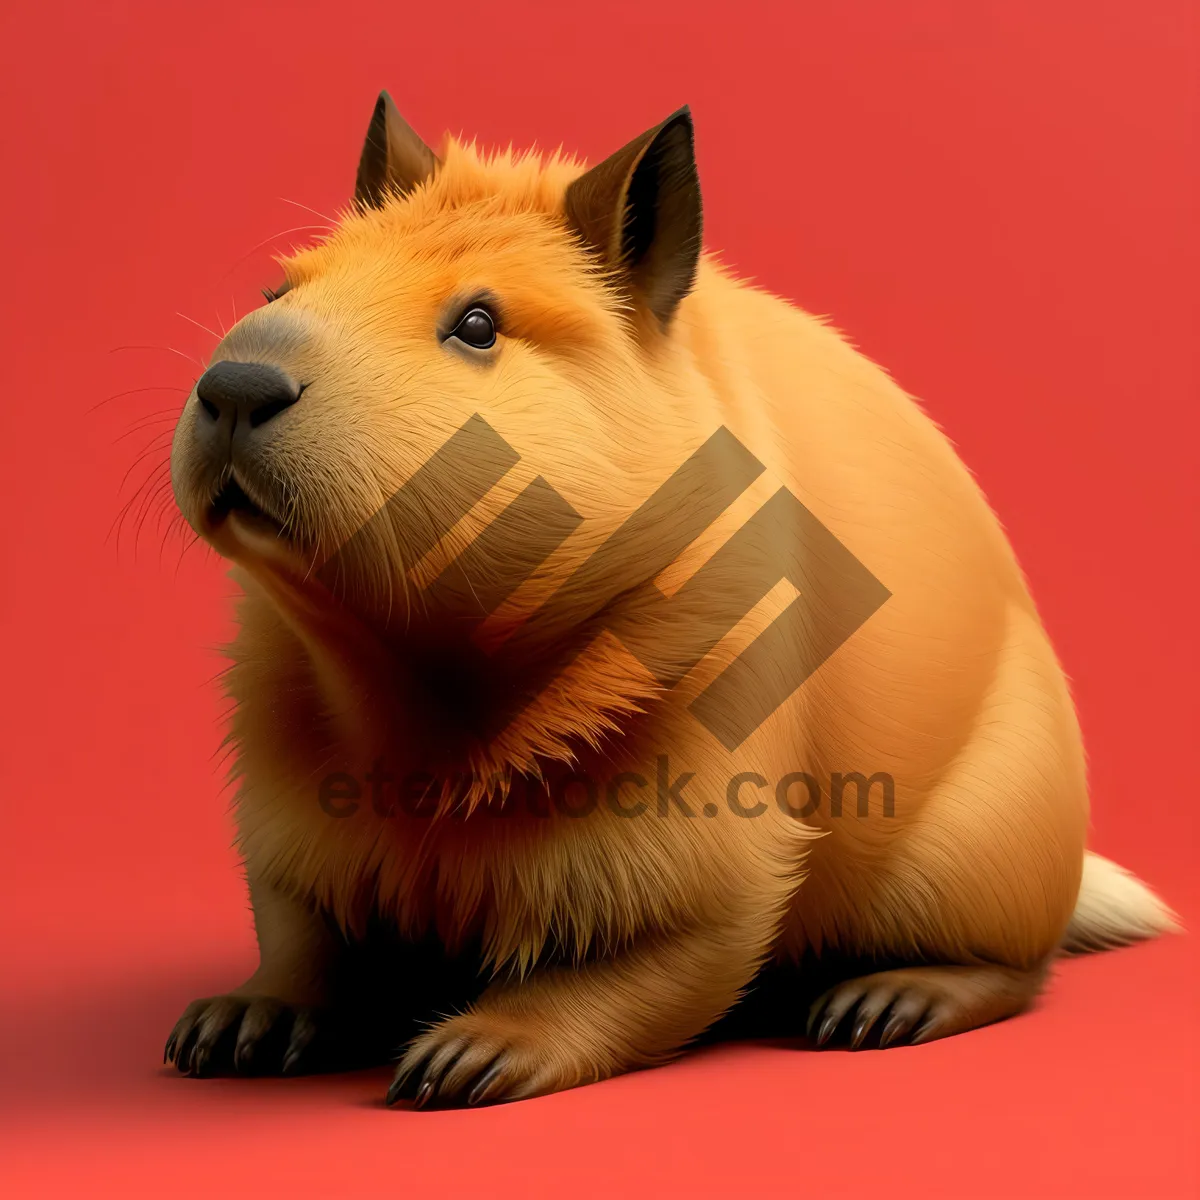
388;1012;592;1109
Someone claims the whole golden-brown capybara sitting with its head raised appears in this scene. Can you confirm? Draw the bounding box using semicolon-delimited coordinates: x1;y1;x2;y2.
167;94;1174;1106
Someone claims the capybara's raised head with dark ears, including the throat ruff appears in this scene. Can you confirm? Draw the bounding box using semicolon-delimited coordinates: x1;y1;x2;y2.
172;94;763;763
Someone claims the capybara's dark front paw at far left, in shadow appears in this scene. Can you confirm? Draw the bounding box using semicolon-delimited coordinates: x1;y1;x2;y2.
163;994;328;1075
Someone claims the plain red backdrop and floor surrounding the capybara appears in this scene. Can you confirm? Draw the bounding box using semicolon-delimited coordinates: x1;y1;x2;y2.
0;0;1200;1198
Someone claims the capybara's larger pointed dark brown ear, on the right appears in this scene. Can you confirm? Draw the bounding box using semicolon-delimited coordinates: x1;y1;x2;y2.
565;106;702;328
